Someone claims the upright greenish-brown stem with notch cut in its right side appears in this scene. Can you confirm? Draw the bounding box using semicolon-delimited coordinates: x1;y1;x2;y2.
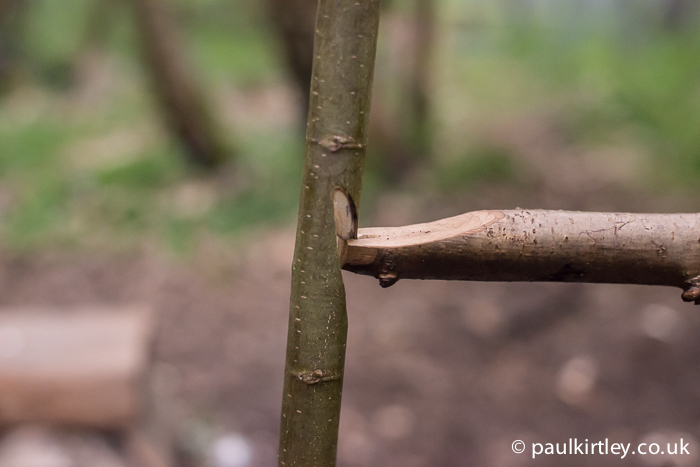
279;0;379;466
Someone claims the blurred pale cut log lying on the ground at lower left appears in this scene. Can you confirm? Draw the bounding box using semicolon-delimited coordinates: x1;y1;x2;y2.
0;309;152;429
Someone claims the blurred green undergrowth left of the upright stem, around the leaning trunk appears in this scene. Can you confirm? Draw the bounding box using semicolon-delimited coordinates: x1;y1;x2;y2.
0;0;303;252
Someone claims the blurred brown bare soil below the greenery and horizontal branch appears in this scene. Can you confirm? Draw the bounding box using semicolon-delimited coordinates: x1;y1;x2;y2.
0;176;700;467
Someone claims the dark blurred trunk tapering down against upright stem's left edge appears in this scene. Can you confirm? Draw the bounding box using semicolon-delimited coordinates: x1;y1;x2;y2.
267;0;318;121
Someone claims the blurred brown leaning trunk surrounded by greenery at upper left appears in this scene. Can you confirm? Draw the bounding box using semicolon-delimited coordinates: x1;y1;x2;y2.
131;0;229;167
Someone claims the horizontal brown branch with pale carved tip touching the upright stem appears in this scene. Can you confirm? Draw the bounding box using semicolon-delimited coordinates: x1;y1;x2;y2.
343;209;700;304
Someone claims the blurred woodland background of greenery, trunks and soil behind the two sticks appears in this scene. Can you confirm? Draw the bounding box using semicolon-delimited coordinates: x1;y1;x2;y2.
0;0;700;467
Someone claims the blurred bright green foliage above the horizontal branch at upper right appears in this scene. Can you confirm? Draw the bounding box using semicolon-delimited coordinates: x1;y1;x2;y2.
438;0;700;187
